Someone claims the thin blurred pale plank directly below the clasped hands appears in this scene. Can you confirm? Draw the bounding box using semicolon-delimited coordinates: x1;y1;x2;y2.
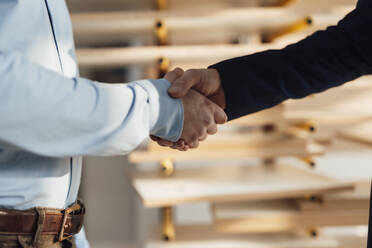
129;142;325;163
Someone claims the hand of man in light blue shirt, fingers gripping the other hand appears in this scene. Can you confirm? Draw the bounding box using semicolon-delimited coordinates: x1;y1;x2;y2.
151;68;227;151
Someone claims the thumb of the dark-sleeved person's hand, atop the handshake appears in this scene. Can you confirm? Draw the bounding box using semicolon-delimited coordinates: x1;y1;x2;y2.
168;69;201;98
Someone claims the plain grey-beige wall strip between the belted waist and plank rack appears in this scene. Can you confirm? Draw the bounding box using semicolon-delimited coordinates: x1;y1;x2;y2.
81;156;136;247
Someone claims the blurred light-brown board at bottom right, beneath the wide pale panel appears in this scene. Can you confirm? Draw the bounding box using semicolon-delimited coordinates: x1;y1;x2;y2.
212;181;371;233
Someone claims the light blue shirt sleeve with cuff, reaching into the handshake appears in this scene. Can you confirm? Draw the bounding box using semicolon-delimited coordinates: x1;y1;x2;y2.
0;52;183;157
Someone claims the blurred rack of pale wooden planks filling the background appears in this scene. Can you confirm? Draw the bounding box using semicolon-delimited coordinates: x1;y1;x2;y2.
70;0;372;248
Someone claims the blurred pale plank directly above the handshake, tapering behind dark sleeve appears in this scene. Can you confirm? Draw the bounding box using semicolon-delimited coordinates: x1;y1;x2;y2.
77;45;276;67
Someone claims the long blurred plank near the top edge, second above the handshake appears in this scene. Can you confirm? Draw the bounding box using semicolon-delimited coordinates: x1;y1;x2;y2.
71;8;304;35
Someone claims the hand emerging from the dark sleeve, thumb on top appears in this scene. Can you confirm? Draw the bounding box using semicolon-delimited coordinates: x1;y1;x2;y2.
166;68;226;109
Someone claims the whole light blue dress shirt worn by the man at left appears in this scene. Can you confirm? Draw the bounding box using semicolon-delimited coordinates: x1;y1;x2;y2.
0;0;183;247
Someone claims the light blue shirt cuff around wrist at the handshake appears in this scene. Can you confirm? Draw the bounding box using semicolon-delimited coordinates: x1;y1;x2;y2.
136;79;184;142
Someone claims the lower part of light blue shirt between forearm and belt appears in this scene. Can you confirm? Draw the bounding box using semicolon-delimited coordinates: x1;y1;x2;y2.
0;150;81;210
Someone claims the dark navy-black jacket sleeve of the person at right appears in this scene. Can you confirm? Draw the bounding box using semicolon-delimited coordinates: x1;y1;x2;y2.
210;0;372;120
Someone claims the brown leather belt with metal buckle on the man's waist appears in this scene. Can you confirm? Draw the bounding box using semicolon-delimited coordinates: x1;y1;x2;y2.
0;203;85;241
